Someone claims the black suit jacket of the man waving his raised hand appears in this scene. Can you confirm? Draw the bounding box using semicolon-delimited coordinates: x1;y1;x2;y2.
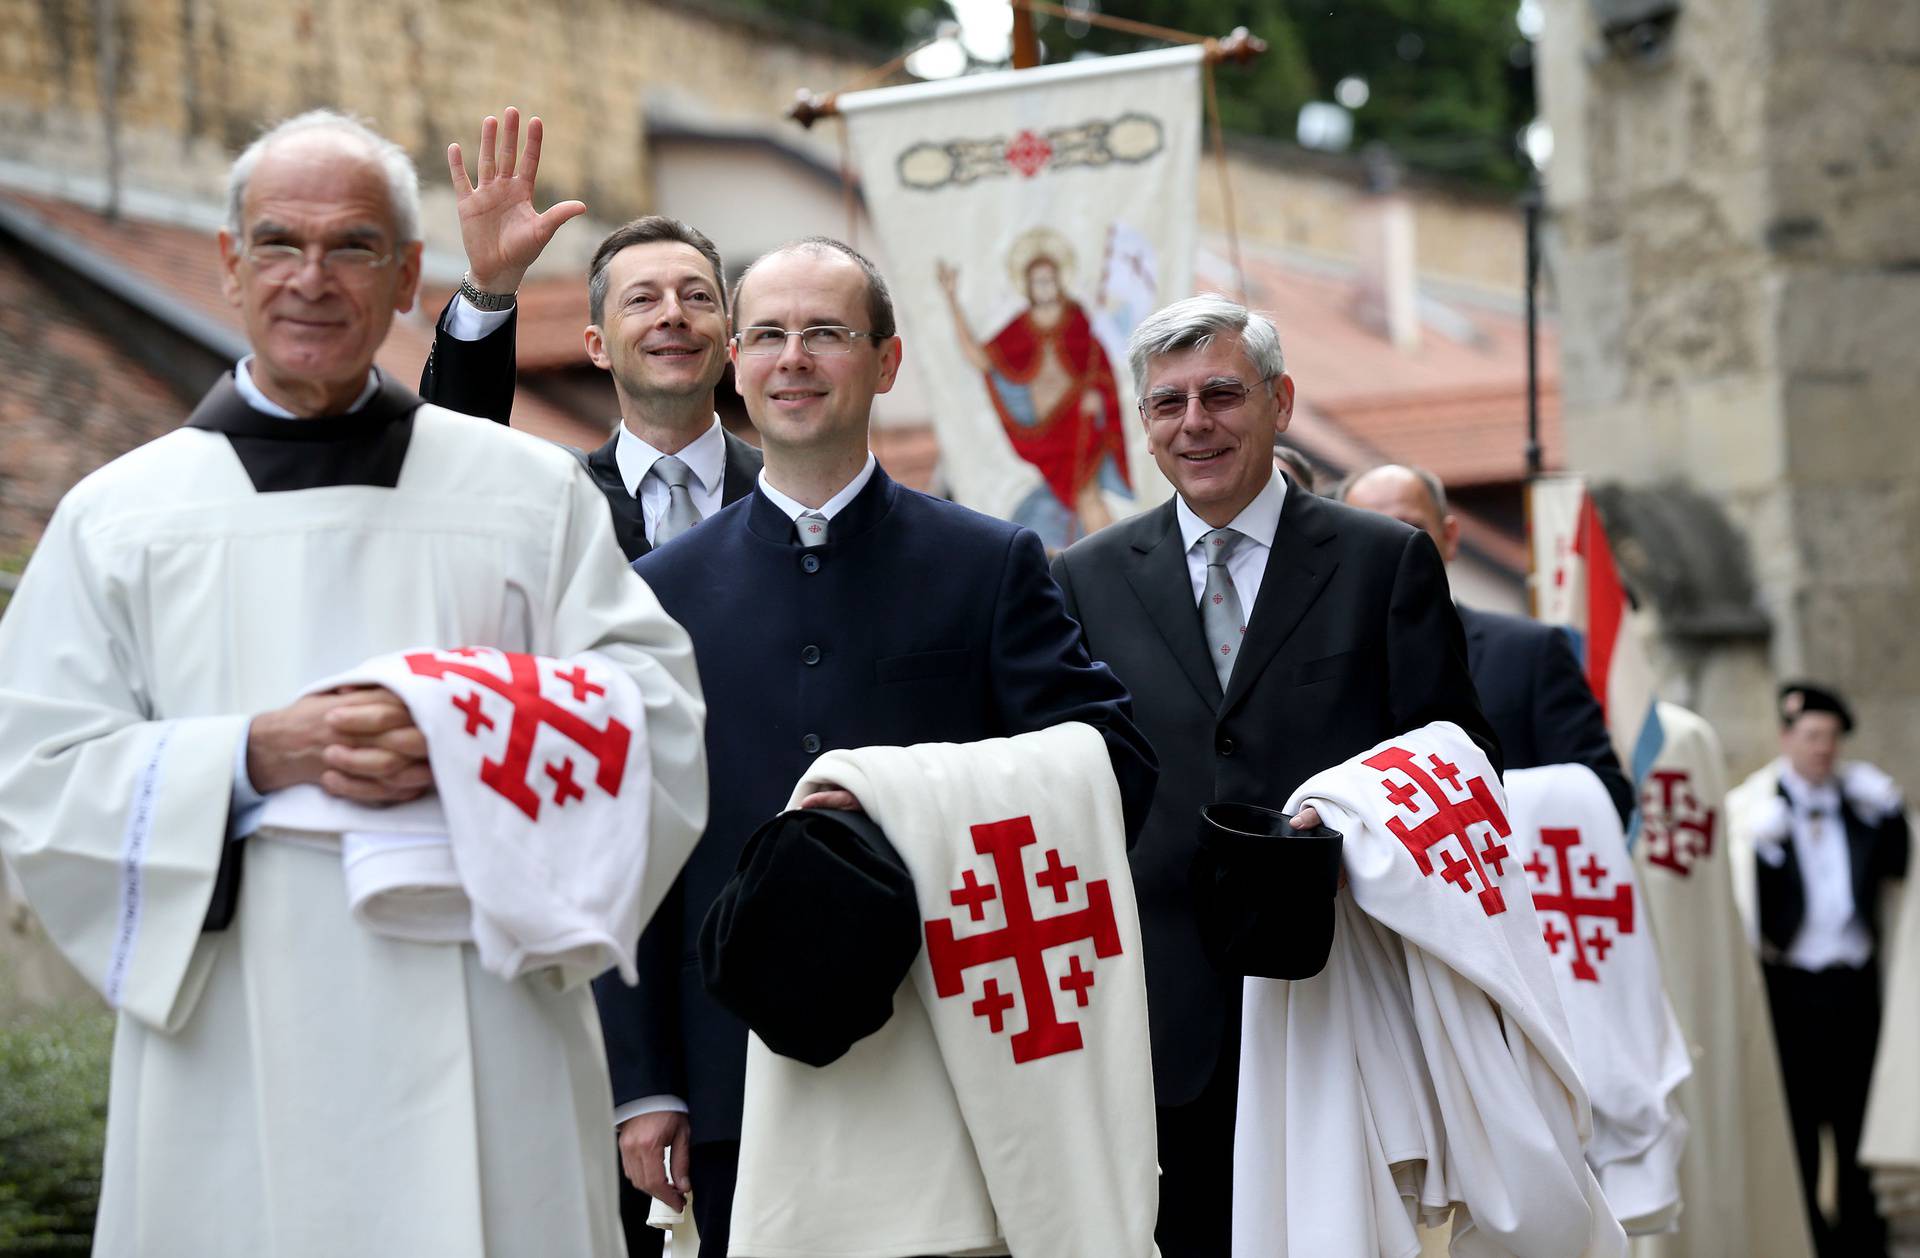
420;298;762;559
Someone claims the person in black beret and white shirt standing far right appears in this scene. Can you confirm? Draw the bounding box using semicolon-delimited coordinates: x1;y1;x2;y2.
1728;682;1910;1258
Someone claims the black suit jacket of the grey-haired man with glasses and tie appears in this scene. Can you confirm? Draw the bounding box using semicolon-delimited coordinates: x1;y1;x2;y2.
1054;486;1500;1106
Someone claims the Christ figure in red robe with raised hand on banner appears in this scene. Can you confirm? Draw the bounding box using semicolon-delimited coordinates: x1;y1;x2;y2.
937;227;1133;545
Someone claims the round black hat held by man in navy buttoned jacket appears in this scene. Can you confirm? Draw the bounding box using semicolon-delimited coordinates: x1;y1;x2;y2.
701;809;920;1066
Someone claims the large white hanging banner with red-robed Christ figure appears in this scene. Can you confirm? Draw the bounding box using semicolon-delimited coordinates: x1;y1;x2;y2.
839;48;1202;547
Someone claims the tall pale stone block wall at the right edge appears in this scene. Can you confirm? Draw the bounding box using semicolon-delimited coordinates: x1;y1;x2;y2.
1538;0;1920;775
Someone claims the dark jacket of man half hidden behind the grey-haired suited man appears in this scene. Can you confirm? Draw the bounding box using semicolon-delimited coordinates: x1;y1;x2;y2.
1455;605;1634;826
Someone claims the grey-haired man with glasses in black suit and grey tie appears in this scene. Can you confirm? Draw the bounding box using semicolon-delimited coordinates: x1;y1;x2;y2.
1054;296;1500;1258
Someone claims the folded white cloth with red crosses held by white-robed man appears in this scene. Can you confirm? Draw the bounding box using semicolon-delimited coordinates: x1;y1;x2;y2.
274;647;651;983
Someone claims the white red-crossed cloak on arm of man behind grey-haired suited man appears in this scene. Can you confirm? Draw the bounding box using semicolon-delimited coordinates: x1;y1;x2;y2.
1507;764;1693;1235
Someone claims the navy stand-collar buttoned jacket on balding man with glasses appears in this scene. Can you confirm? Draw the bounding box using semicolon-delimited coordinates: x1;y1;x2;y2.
595;469;1154;1143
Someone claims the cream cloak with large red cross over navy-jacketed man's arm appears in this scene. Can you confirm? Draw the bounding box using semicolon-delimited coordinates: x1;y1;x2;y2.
728;722;1158;1258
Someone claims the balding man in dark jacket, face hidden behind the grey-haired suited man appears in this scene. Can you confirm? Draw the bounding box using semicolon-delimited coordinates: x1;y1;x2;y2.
1334;463;1634;826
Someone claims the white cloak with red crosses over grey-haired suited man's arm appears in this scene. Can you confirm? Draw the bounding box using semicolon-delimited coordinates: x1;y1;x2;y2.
1233;722;1626;1258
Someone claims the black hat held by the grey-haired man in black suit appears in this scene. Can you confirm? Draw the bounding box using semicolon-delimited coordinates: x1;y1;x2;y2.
1192;803;1342;978
